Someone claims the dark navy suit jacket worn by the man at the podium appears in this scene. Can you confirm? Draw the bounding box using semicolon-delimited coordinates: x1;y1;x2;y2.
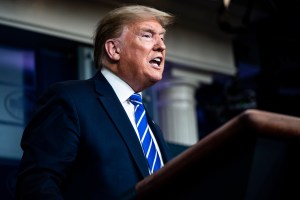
17;72;171;200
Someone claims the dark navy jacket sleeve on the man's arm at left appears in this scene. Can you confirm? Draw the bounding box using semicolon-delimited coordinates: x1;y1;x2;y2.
16;83;80;200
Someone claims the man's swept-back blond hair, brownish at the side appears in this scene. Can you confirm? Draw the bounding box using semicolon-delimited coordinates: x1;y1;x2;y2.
94;5;174;69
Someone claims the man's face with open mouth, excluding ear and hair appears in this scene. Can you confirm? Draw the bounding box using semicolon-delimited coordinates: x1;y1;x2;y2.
118;20;166;92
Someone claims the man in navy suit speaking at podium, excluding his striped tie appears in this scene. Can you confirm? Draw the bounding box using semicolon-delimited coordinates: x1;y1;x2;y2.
17;5;173;200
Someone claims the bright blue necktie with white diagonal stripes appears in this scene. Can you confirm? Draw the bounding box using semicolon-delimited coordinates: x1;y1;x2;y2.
129;93;161;174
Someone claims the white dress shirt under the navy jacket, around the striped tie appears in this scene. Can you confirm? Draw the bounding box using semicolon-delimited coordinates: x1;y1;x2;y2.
101;67;164;166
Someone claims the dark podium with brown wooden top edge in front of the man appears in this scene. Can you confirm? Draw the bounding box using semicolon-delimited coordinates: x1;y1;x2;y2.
135;109;300;200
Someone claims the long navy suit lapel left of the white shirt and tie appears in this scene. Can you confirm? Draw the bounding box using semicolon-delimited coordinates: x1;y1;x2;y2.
95;72;149;177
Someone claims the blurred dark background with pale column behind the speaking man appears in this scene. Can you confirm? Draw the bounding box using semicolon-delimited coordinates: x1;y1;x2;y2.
0;0;300;200
